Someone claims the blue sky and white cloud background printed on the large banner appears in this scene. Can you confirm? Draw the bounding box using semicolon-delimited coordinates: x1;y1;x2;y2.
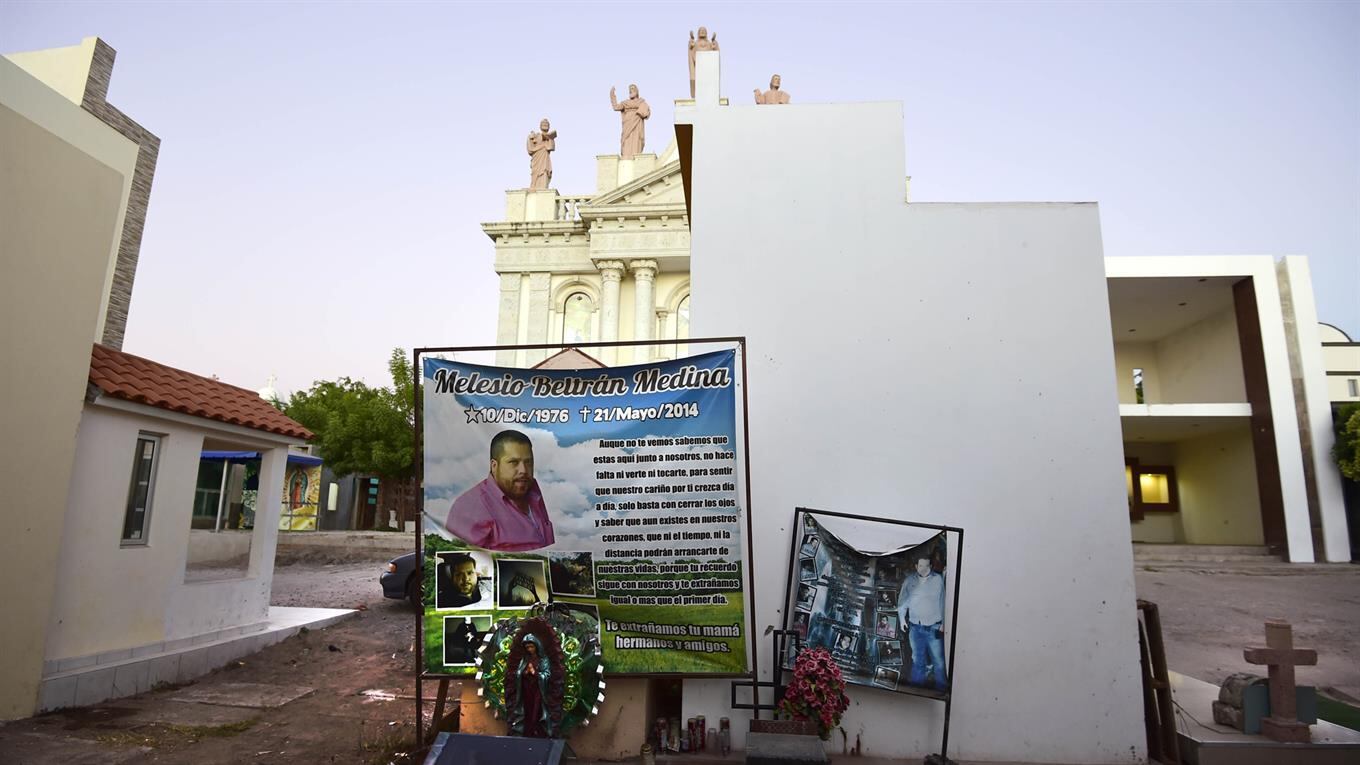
423;351;740;558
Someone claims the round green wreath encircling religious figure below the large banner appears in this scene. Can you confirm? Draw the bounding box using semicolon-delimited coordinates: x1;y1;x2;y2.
476;603;605;738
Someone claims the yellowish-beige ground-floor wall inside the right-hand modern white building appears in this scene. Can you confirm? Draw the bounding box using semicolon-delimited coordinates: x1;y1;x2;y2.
1174;425;1265;544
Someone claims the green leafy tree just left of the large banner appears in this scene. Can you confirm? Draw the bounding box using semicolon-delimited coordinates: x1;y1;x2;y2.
283;348;415;478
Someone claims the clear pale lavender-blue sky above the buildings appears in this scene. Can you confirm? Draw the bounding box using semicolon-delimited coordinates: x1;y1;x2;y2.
0;0;1360;395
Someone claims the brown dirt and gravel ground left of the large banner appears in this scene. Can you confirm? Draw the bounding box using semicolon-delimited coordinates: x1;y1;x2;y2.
0;558;415;765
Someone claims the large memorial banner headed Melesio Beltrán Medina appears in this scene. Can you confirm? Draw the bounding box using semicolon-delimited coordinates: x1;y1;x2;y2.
422;350;748;675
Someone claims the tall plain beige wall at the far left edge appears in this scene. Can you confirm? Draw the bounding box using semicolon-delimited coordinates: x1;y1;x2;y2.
0;59;137;719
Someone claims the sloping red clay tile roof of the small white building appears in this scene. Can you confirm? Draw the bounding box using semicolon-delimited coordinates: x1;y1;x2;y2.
90;343;311;438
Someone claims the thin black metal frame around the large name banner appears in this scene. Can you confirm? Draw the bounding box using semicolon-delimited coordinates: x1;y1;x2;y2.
411;335;761;742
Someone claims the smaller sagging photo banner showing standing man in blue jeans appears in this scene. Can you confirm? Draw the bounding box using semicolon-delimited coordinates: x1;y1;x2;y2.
785;513;952;696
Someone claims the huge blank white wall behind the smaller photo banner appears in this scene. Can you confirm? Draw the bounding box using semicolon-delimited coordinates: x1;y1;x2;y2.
677;98;1144;762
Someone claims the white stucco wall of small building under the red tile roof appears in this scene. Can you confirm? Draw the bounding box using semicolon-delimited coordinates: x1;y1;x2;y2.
46;399;290;660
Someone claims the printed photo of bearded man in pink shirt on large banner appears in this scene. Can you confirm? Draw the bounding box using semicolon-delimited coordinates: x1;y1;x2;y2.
445;430;554;551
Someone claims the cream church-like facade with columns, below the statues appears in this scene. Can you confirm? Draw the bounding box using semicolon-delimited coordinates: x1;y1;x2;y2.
481;144;690;366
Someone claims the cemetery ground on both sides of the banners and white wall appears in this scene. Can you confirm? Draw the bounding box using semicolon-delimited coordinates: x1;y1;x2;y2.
0;544;1360;765
